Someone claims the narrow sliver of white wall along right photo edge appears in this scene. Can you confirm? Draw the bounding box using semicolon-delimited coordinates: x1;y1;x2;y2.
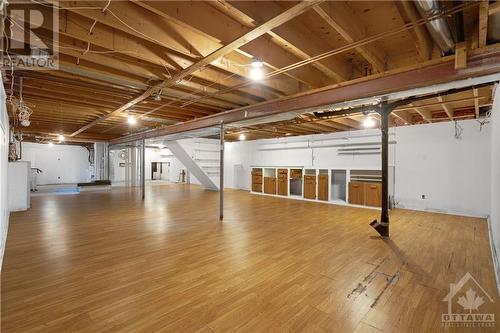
489;85;500;290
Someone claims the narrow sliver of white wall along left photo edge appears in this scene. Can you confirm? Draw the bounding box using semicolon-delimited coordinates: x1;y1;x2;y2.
0;80;9;271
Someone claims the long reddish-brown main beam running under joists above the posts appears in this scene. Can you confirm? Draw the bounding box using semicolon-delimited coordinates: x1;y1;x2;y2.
111;47;500;143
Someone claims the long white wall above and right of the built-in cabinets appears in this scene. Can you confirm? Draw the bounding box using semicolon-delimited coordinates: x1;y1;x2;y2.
225;120;490;217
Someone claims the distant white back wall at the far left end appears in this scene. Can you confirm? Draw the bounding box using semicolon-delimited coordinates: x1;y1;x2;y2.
21;142;91;185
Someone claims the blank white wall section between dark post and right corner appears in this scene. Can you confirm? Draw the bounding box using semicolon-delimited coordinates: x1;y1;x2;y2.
395;120;491;217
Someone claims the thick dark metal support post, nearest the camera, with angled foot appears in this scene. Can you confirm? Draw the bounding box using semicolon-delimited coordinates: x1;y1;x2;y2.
370;104;394;237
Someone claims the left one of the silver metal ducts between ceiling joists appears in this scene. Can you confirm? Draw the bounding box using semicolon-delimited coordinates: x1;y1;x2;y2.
415;0;455;54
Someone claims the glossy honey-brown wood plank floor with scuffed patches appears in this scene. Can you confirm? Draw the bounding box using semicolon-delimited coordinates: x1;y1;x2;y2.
1;185;500;333
